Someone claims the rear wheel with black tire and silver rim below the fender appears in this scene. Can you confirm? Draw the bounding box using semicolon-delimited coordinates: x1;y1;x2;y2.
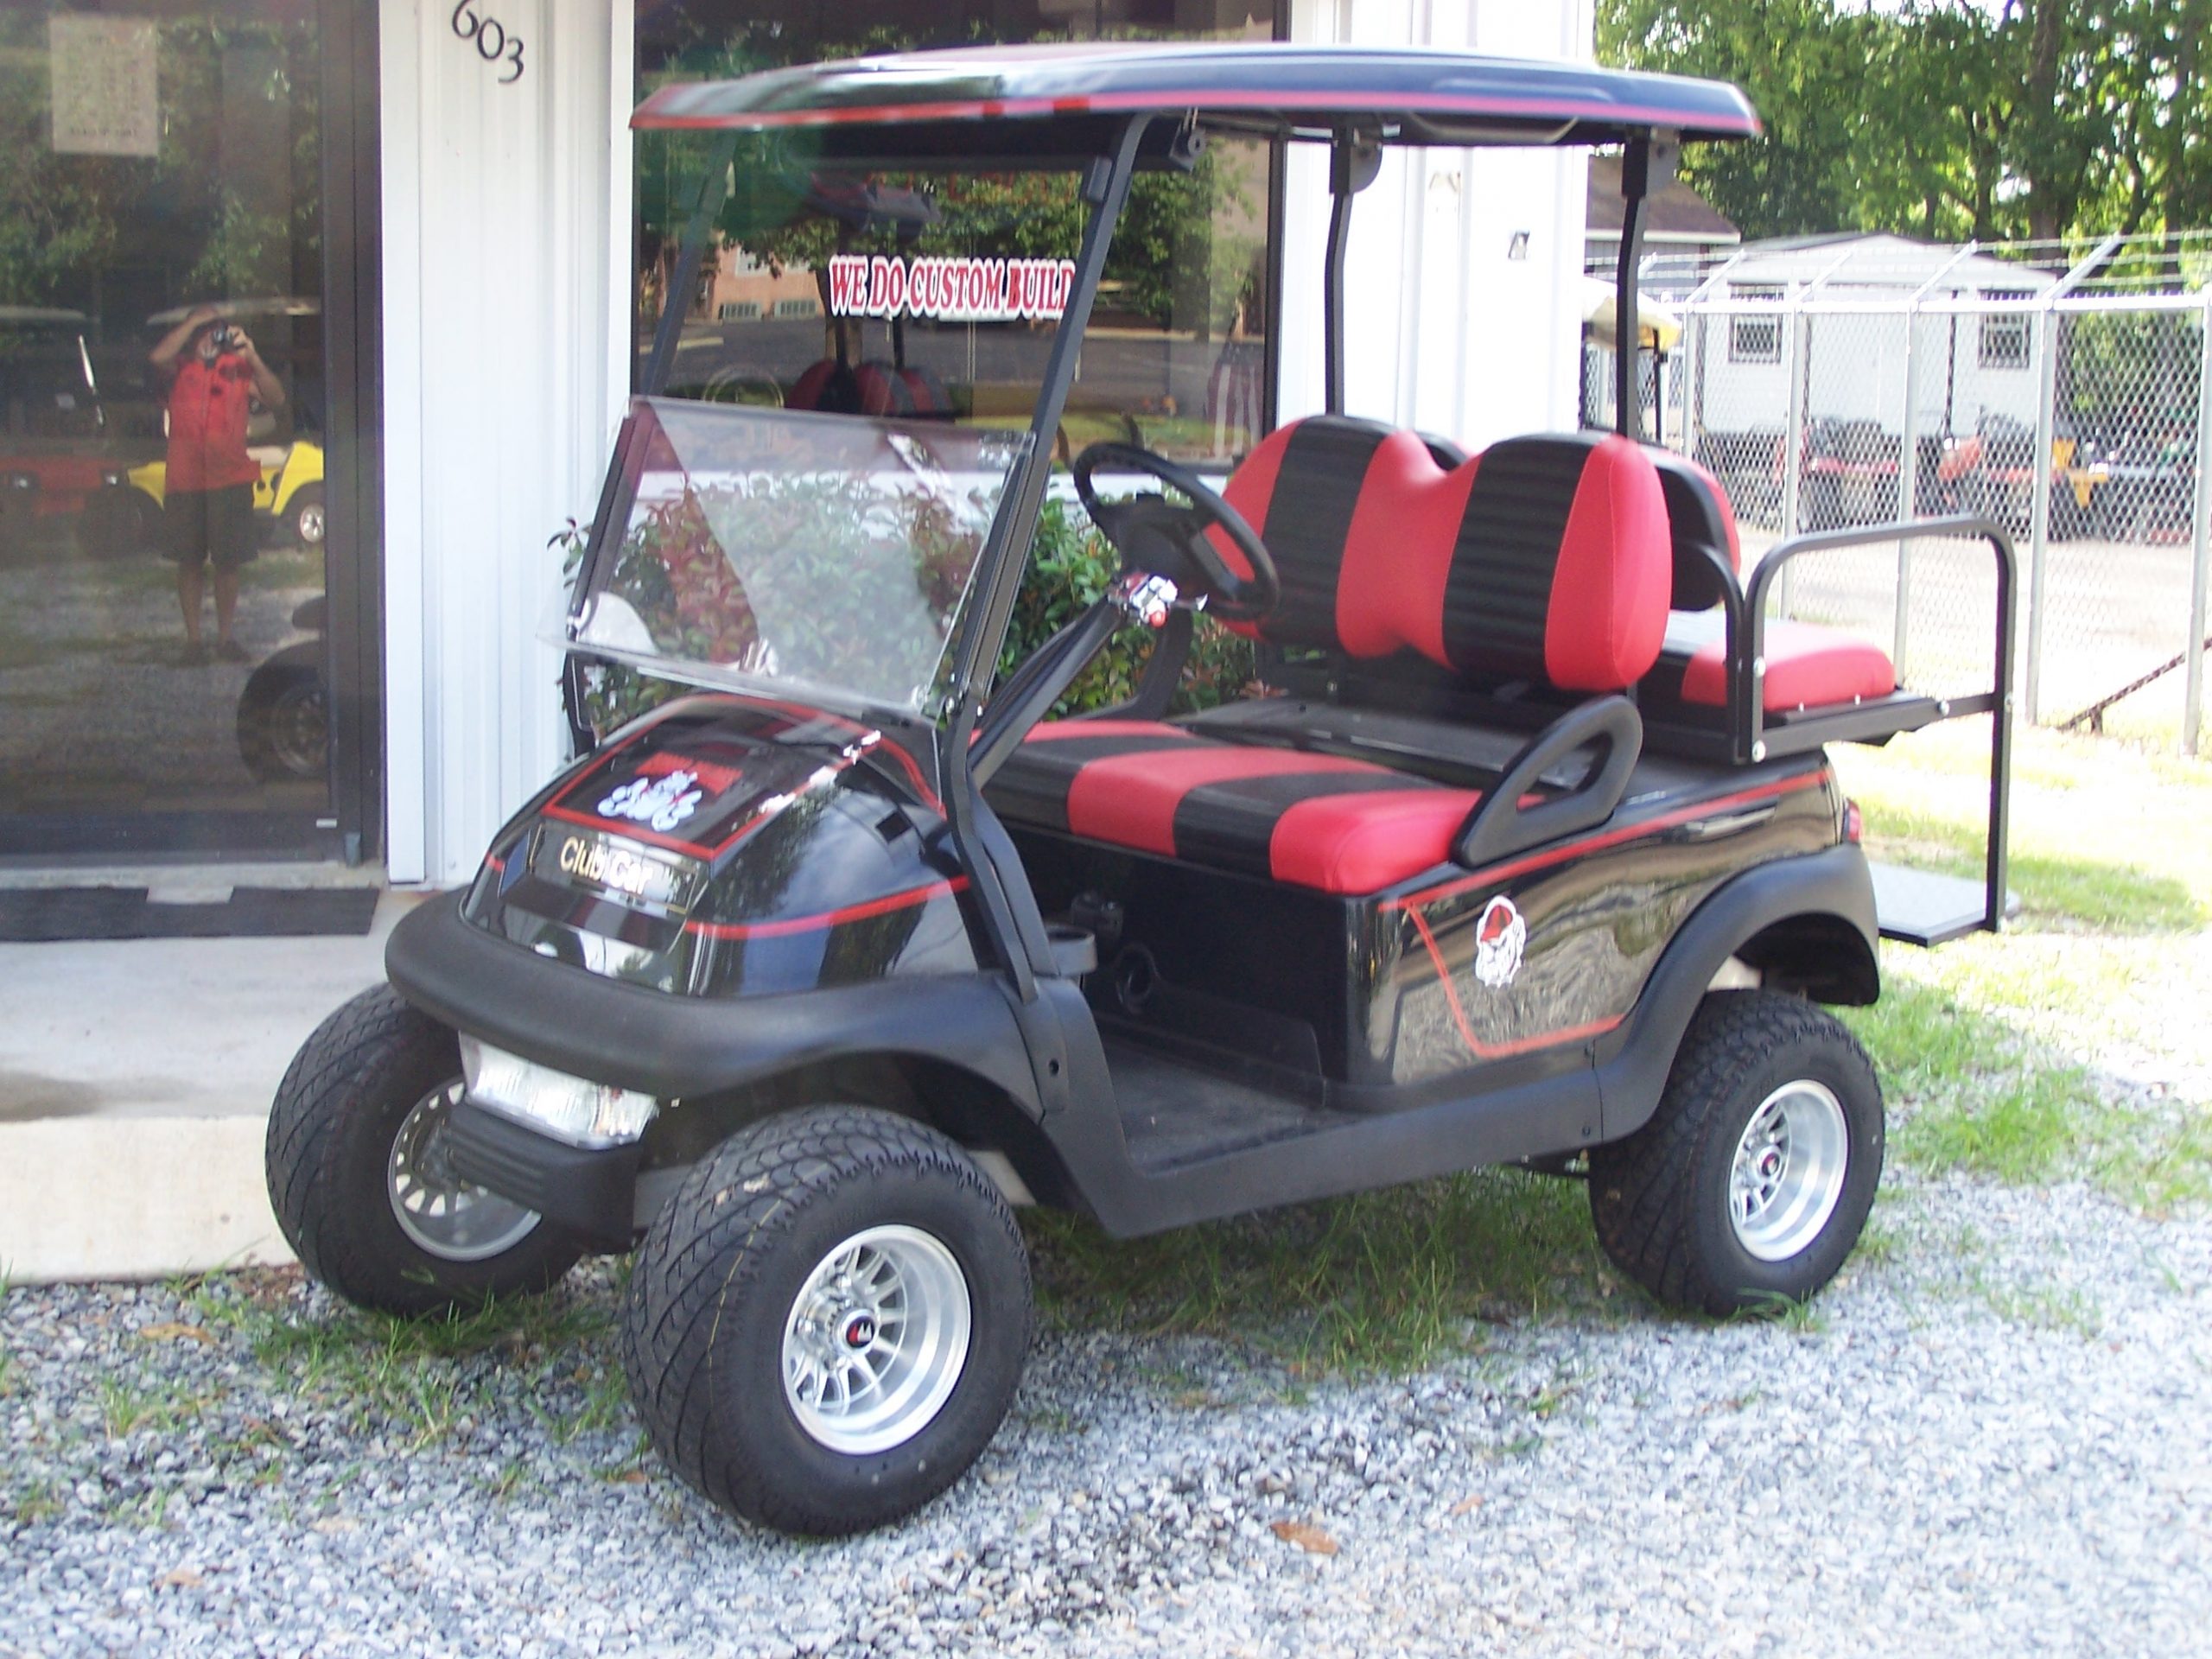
1591;991;1883;1314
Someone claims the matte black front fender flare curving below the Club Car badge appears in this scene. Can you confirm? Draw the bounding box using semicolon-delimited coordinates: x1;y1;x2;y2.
385;893;1044;1117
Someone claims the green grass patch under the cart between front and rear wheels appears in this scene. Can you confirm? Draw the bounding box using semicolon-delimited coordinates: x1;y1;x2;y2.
1024;1170;1617;1378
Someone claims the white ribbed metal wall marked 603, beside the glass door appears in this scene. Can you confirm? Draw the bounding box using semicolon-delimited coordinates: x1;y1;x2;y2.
378;0;632;885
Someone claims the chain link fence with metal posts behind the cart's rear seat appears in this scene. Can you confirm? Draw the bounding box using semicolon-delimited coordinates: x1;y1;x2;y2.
1584;237;2212;752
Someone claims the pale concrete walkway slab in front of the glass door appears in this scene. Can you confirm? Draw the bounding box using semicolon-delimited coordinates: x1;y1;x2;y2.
0;865;418;1283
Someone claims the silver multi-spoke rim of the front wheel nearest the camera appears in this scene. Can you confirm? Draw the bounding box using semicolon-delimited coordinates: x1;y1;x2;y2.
783;1228;971;1455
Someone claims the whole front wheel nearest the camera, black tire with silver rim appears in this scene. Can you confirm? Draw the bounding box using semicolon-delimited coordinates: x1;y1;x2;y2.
621;1106;1031;1537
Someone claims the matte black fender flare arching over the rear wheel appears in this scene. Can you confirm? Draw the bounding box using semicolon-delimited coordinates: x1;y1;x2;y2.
1595;842;1880;1141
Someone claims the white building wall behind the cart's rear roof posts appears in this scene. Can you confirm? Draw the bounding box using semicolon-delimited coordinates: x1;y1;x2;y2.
1276;0;1595;449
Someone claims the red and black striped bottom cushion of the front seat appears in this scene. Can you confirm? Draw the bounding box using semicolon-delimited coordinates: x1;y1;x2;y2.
991;721;1482;893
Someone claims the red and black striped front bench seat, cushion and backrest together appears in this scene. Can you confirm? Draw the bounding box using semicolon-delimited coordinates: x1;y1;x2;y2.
991;416;1668;893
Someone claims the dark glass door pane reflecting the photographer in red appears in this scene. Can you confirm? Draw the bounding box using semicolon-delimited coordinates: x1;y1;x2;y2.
0;13;329;854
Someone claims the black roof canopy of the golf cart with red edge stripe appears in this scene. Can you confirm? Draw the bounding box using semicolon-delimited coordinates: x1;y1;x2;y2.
631;42;1758;156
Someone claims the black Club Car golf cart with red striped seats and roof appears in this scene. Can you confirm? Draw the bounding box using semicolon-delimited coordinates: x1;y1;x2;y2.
268;44;2011;1533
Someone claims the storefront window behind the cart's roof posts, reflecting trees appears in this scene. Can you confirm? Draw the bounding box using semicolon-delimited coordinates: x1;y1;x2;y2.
635;0;1276;469
